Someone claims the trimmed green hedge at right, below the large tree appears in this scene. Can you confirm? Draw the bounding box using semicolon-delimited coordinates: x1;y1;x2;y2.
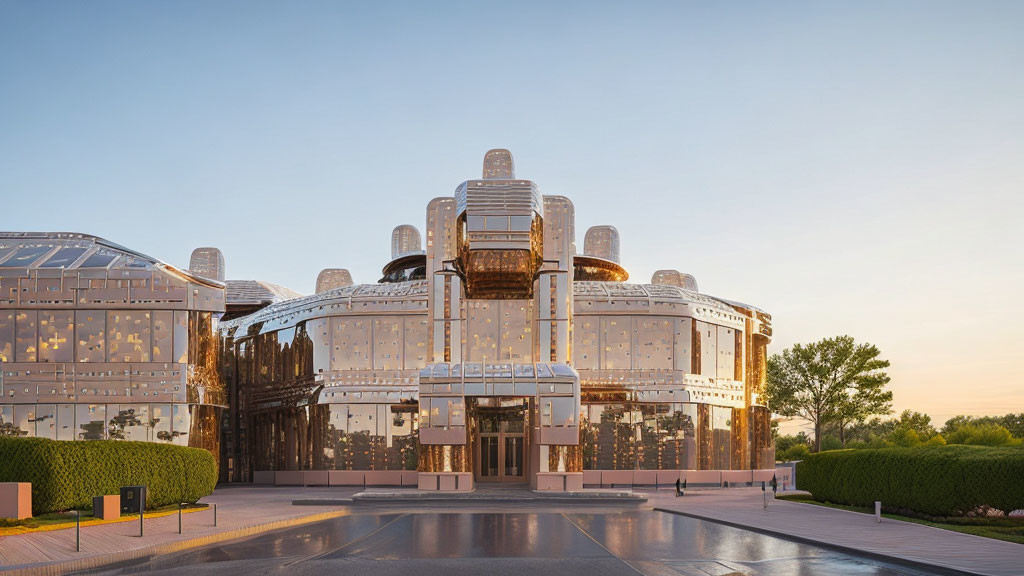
797;446;1024;517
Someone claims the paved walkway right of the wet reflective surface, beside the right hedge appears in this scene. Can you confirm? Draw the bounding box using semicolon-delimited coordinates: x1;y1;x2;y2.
646;488;1024;576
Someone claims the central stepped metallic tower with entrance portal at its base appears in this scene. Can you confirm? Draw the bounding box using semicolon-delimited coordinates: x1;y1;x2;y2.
420;150;583;490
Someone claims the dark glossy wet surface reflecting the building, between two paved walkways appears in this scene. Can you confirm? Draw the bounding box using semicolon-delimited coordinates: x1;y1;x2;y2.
105;509;932;576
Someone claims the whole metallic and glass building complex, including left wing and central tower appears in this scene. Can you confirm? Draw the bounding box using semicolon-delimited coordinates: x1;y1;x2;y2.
0;150;774;490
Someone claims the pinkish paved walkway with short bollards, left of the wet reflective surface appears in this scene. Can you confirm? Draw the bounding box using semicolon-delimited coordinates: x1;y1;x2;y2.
0;485;361;576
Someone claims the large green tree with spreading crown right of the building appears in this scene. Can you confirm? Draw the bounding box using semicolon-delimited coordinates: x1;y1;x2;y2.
765;336;892;452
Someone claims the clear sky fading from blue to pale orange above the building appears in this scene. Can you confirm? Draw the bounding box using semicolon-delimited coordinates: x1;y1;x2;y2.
0;0;1024;420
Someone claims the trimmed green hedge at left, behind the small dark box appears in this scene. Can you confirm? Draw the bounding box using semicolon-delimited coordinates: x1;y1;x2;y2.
0;437;217;516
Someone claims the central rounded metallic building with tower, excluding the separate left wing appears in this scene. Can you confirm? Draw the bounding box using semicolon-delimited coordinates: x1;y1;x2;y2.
220;150;774;490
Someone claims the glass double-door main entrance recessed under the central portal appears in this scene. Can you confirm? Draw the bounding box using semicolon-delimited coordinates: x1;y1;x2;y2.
474;398;529;483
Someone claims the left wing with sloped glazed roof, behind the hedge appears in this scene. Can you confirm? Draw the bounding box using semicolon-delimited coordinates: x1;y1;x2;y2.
0;233;227;454
